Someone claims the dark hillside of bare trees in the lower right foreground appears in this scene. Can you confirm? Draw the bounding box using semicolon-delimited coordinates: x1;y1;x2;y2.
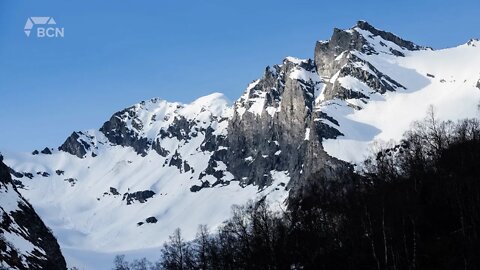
114;113;480;270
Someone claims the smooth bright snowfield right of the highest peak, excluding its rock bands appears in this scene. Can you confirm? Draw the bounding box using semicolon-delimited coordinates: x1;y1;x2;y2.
318;43;480;164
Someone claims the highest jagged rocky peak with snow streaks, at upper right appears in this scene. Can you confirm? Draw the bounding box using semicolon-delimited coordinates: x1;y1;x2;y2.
314;21;414;102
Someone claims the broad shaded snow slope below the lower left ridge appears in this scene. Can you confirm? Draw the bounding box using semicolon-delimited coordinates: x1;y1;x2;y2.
1;94;289;269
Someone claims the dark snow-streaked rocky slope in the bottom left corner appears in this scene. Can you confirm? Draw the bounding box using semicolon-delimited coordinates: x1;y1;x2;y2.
0;161;67;269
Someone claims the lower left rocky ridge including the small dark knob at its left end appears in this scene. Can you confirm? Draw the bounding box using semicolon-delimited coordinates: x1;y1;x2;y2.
59;93;229;158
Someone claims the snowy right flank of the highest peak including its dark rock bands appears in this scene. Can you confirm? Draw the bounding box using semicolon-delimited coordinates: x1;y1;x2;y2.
318;23;480;163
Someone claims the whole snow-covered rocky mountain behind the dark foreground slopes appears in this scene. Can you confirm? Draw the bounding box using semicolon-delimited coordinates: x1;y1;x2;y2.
6;21;480;268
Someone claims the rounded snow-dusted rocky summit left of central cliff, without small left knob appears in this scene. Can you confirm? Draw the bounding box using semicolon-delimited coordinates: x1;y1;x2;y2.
95;94;231;162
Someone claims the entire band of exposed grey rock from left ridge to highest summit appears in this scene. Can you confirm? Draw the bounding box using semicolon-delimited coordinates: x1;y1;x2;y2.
51;21;425;192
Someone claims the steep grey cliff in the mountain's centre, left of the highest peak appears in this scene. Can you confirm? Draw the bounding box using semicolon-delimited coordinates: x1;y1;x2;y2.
224;57;346;187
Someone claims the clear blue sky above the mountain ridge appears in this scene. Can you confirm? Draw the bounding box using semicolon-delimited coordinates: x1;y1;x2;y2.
0;0;480;151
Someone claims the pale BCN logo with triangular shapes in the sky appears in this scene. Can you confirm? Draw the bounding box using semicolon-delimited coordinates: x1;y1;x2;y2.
23;17;65;38
